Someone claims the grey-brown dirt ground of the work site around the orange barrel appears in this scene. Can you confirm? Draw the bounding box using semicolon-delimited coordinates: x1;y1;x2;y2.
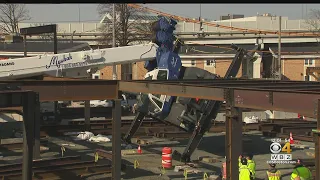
0;132;314;180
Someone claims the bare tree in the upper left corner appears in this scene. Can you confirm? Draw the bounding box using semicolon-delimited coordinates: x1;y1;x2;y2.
0;4;31;34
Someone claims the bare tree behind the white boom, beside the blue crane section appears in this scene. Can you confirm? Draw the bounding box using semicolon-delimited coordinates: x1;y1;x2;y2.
97;4;152;46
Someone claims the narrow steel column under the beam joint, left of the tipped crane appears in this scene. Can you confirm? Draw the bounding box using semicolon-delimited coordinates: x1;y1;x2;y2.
112;99;121;180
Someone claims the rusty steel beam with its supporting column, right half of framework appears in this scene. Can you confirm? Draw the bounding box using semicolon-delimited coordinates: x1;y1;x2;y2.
119;79;320;180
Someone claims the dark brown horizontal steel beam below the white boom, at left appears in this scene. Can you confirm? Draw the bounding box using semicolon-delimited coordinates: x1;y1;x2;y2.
0;80;118;101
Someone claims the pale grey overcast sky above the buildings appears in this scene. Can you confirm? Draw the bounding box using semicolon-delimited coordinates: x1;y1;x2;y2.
26;3;320;23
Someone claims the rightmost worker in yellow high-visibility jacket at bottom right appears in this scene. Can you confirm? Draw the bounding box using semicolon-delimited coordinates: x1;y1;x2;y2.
291;159;313;180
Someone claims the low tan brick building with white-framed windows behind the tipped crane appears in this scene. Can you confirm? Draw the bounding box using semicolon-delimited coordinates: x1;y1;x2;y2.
100;41;320;81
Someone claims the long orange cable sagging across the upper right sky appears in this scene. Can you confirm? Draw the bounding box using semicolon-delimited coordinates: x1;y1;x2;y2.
128;4;320;36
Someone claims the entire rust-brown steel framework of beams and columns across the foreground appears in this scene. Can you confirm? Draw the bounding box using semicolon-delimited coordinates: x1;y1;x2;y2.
0;79;320;180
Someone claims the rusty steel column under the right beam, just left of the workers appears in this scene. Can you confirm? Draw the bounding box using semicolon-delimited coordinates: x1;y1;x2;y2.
225;89;242;180
